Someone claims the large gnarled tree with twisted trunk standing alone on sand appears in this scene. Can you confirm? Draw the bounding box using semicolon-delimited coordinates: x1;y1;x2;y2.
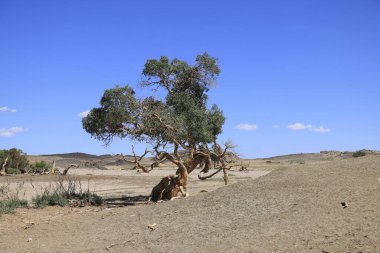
82;53;232;201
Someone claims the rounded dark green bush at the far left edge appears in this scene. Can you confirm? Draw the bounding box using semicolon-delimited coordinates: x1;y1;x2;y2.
0;148;29;174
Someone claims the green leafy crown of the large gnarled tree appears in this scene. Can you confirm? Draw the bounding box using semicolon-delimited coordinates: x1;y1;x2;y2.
82;53;225;147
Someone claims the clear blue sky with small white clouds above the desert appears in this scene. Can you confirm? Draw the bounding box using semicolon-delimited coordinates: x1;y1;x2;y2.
0;0;380;158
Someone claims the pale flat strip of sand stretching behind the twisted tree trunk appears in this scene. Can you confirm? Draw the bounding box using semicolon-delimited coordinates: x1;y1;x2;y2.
0;167;270;201
